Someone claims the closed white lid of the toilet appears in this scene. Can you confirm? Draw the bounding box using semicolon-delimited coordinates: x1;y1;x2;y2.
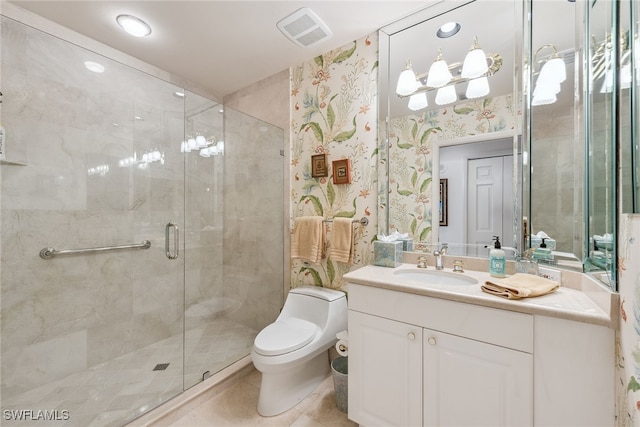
254;318;318;356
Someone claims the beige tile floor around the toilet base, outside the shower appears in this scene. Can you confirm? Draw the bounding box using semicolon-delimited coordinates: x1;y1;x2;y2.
168;369;358;427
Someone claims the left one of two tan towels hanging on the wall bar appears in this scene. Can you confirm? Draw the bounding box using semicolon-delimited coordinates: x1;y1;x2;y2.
291;216;325;264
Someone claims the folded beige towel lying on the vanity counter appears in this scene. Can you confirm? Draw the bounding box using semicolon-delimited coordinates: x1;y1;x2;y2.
482;273;560;299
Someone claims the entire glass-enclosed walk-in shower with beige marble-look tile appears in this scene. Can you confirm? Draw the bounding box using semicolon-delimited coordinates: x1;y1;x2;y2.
0;16;284;426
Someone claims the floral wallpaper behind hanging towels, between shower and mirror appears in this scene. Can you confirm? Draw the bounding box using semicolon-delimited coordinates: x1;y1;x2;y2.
290;34;378;289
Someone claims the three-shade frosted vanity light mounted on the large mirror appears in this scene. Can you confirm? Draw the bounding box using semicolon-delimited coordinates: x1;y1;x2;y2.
396;37;502;111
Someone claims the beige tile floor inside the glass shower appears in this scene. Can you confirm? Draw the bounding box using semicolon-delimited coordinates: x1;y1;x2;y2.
2;319;258;427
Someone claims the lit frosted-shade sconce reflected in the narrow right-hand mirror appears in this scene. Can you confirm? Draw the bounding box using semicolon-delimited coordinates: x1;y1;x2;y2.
531;44;567;106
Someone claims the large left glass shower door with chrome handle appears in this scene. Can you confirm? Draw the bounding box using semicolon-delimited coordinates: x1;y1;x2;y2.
0;17;184;426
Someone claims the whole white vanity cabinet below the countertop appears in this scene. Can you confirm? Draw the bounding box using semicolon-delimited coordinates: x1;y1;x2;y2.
349;283;615;426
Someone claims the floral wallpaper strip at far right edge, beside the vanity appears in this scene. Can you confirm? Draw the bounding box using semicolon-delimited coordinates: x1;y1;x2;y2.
616;215;640;426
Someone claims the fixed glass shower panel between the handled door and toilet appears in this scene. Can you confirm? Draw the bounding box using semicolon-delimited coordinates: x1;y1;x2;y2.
185;102;284;388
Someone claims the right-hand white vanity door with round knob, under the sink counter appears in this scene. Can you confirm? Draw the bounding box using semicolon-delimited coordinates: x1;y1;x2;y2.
423;329;533;427
